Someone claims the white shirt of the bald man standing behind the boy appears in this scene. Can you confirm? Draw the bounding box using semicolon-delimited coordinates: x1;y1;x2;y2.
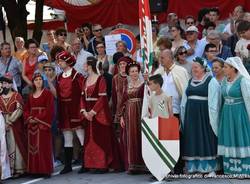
162;72;181;114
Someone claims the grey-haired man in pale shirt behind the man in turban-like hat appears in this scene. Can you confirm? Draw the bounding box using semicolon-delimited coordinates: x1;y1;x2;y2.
72;38;93;77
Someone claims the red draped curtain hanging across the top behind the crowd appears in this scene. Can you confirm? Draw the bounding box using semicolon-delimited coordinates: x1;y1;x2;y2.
45;0;250;31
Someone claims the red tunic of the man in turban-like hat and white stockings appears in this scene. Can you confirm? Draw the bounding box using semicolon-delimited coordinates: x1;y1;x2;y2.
56;69;83;130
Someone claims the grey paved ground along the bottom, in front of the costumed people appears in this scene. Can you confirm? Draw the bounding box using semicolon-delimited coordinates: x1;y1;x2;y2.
3;167;250;184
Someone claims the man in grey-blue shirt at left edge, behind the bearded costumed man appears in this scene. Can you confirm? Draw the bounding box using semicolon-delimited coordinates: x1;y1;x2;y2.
0;42;22;92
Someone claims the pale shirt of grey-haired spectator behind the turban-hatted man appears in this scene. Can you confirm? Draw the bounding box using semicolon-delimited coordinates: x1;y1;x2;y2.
74;49;93;76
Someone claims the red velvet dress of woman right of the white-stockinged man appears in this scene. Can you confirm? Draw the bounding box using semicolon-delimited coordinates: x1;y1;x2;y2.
82;77;120;170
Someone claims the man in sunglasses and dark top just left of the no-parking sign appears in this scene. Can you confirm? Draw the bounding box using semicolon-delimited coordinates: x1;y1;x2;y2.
88;24;104;56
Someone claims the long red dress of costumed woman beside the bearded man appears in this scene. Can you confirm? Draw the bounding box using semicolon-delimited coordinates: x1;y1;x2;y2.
24;89;54;174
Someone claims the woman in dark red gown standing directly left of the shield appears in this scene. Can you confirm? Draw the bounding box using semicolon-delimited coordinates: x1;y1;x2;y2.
119;62;146;174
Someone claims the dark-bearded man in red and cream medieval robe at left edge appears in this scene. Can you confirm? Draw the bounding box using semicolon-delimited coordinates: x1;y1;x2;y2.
0;73;27;177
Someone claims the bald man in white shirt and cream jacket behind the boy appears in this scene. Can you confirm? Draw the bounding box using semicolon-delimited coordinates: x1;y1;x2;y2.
161;49;189;174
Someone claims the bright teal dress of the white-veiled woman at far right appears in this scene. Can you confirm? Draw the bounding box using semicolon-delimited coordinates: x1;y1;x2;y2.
218;76;250;175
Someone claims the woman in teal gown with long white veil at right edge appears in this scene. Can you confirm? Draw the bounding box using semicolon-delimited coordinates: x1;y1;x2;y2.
218;57;250;175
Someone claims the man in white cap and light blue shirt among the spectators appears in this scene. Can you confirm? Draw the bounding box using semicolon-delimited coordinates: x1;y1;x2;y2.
183;26;206;62
